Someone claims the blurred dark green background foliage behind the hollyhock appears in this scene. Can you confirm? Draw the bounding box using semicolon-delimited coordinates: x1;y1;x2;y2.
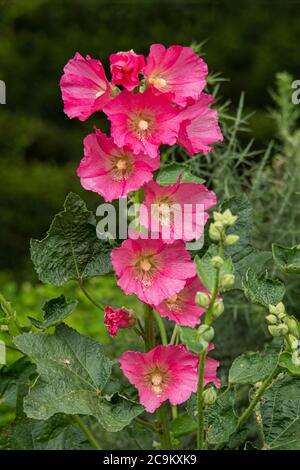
0;0;300;392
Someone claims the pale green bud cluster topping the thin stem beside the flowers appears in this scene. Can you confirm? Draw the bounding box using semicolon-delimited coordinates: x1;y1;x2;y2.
209;209;240;246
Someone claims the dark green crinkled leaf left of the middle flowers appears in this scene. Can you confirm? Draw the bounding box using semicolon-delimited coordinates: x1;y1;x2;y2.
31;193;111;286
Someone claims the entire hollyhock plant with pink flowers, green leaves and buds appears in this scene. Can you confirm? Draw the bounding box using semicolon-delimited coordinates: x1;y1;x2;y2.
0;44;300;451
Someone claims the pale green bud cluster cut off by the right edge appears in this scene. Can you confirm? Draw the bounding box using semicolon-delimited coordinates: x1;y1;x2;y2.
266;302;300;365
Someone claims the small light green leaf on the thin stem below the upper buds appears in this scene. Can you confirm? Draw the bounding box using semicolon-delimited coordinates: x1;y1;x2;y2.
194;245;234;292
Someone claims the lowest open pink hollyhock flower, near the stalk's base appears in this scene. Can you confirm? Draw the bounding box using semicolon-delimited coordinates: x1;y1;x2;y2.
119;344;218;413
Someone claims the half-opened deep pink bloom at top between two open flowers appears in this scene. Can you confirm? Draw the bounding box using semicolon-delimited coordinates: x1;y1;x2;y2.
109;51;145;91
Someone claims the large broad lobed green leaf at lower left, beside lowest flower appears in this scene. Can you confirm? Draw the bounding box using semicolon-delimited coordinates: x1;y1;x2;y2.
15;324;143;432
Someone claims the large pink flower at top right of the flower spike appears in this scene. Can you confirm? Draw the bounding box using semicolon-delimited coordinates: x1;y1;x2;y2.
143;44;208;106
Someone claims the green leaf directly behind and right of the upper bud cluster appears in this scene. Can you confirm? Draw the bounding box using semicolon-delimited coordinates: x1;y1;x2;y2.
221;194;272;289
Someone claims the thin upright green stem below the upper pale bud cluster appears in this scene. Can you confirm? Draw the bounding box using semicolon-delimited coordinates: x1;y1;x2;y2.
197;240;224;450
